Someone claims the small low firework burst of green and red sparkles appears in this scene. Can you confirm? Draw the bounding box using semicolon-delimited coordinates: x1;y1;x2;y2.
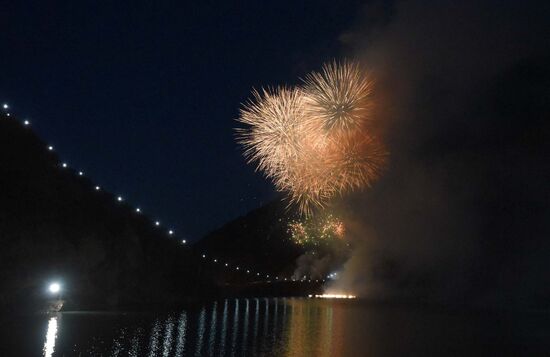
288;214;345;247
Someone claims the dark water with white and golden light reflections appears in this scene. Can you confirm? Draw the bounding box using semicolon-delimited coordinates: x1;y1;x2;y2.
0;298;550;356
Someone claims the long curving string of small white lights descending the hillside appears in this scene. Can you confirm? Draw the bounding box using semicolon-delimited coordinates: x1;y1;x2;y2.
2;103;336;283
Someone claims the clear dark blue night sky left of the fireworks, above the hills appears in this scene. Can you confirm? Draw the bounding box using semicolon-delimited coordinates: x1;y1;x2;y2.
0;1;361;239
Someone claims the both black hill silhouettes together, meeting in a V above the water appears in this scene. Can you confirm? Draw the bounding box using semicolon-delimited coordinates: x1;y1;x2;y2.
0;113;320;310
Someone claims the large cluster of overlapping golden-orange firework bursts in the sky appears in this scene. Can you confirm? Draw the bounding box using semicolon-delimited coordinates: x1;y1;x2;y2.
237;62;387;215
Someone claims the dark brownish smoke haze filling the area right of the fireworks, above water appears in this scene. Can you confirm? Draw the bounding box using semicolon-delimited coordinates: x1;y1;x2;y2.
329;1;550;306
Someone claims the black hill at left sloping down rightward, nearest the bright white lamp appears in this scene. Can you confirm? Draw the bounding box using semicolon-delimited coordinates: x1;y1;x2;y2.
0;113;215;309
